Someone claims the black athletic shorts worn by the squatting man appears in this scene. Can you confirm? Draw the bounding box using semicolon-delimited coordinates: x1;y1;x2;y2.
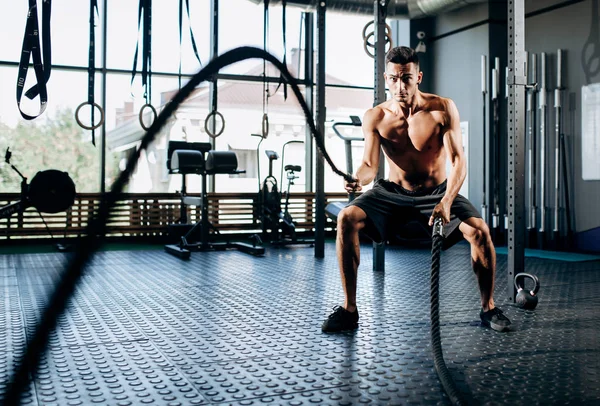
348;179;481;242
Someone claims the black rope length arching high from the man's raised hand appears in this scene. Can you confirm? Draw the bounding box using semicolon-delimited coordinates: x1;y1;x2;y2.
4;47;356;405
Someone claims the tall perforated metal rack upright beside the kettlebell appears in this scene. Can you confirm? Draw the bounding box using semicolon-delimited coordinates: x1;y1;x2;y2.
507;0;526;302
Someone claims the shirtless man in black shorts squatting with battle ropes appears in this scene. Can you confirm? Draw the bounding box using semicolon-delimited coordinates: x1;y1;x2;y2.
322;47;510;332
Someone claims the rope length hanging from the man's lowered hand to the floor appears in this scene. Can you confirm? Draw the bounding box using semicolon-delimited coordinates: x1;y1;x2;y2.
431;218;466;405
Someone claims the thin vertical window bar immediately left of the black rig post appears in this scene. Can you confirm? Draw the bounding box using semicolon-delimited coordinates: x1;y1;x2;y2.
298;13;315;192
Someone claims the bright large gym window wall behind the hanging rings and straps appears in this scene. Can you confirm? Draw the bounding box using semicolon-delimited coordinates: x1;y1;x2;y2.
0;0;380;192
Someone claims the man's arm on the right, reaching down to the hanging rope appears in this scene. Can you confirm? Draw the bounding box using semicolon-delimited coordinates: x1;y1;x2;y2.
429;99;467;225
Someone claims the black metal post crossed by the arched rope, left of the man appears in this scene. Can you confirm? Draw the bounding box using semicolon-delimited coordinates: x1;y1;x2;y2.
315;0;327;258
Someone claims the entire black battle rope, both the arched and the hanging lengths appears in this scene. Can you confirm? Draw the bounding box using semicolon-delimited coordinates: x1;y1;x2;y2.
4;47;464;405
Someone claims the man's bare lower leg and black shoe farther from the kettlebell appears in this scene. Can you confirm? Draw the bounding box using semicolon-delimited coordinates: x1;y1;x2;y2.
321;206;367;332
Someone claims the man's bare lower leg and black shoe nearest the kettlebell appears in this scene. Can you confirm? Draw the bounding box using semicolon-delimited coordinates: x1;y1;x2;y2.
459;217;510;331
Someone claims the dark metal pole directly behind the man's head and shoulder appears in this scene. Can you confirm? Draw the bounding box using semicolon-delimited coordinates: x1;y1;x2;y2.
373;0;388;271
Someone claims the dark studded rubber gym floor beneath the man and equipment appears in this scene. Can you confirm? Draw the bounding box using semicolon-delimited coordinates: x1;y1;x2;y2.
0;242;600;405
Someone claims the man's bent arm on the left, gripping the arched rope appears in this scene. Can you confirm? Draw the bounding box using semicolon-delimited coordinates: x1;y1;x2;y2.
355;107;384;190
